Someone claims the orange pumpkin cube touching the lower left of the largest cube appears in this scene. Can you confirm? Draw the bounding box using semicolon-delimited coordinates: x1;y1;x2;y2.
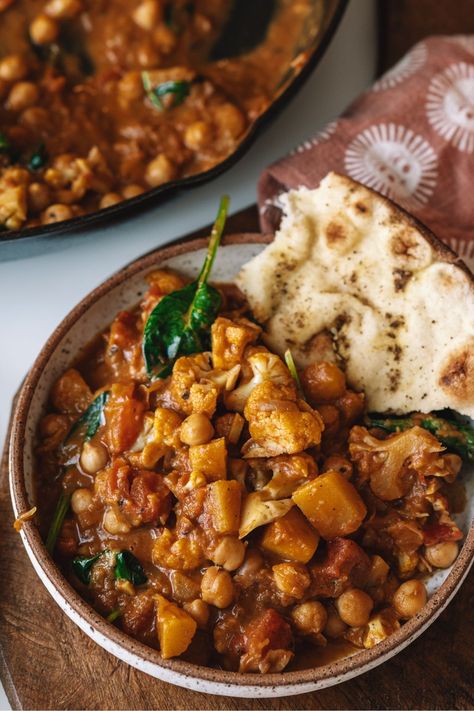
260;507;319;563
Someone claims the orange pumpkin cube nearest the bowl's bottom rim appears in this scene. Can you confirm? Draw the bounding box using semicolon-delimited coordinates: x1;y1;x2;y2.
156;595;197;659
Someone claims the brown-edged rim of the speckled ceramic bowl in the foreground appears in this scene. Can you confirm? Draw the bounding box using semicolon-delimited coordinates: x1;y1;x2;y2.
9;233;474;693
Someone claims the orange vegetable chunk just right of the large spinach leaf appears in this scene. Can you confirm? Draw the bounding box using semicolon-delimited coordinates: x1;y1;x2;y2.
211;316;261;370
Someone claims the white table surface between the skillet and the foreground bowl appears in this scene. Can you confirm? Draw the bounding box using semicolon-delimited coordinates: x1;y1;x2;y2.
0;0;377;709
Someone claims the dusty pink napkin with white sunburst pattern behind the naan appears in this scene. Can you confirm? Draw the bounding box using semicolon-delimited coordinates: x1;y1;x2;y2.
258;35;474;269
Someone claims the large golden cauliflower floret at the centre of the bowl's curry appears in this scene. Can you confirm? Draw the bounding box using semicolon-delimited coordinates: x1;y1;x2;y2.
244;380;324;457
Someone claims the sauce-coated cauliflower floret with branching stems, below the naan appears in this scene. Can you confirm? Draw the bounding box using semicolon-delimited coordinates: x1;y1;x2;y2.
349;426;444;501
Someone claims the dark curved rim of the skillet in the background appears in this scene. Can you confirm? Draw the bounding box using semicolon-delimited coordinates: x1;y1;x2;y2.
0;0;350;250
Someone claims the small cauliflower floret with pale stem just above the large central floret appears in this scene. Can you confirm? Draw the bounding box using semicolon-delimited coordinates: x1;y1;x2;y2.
224;348;293;412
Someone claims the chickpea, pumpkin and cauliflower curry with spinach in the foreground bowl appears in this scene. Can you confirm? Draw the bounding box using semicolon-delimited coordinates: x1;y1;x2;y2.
30;197;473;673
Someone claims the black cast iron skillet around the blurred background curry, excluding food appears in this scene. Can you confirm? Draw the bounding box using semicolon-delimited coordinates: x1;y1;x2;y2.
0;0;349;254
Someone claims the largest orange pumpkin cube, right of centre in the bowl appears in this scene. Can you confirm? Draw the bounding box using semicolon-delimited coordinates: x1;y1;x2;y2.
293;471;367;539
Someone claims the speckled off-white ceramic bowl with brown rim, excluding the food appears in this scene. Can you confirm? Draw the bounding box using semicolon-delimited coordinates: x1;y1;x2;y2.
9;234;474;698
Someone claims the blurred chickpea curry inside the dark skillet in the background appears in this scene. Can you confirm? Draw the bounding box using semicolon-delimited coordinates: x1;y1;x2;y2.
0;0;323;230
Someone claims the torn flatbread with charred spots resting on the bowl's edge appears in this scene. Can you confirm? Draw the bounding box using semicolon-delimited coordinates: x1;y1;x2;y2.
237;173;474;417
